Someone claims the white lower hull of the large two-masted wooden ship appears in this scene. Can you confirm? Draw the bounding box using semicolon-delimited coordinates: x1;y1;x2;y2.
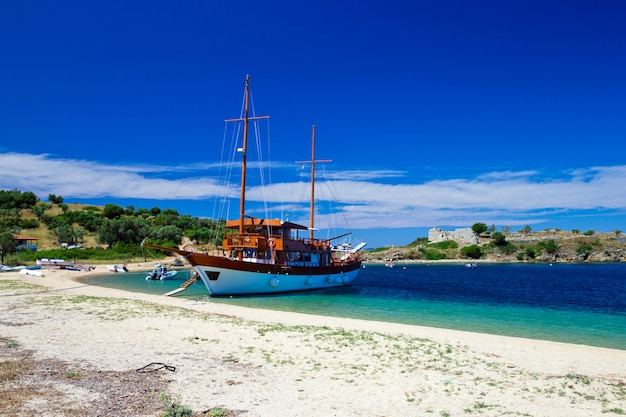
195;265;359;295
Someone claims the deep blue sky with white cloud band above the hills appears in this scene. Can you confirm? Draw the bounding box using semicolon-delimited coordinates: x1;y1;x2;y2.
0;0;626;247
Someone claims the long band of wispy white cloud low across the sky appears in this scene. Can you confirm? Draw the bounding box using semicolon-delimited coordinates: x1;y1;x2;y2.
0;153;626;228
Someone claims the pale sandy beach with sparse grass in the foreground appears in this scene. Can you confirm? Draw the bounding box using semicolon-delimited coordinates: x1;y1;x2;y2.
0;264;626;417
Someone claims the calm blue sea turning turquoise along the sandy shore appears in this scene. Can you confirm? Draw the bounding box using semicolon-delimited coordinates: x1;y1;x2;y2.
88;264;626;350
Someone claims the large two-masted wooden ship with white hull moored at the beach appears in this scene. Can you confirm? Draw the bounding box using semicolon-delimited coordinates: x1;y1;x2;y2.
143;77;365;295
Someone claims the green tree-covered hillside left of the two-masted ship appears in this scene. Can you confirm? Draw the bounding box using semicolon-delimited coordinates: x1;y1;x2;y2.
0;189;223;264
